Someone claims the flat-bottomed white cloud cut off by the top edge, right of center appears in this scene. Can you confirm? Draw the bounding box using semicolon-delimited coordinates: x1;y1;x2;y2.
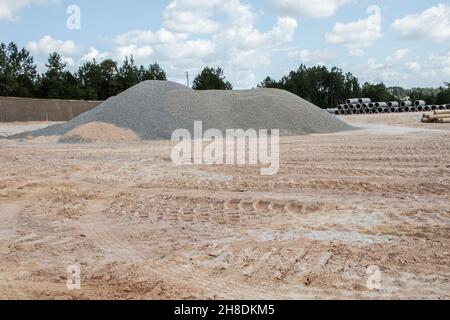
272;0;352;18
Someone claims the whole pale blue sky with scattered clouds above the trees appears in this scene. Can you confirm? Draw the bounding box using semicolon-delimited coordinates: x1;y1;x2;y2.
0;0;450;88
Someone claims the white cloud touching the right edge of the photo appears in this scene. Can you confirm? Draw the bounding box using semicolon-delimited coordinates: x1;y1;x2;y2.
392;3;450;42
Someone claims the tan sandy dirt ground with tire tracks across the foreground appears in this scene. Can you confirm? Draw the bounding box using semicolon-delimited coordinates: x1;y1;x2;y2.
0;115;450;299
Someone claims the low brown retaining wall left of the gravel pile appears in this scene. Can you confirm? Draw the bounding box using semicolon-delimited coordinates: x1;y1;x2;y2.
0;97;102;122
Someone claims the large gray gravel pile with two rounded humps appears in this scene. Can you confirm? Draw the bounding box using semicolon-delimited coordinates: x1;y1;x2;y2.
18;81;352;140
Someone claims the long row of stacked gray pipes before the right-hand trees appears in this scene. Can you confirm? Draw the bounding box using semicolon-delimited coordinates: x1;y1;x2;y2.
327;98;450;115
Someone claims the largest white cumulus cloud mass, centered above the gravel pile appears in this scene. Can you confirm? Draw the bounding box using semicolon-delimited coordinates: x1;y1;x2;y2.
113;0;297;88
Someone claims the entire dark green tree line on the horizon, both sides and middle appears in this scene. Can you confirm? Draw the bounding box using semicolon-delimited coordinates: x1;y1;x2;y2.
0;43;450;108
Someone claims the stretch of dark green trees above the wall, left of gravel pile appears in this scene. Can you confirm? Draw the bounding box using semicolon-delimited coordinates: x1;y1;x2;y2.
0;43;167;100
